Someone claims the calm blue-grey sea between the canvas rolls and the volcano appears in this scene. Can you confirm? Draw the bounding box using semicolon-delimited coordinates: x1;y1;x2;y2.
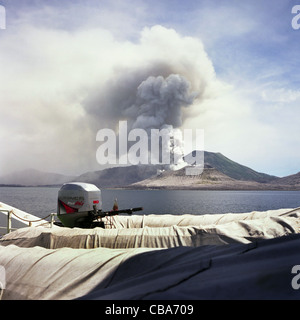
0;187;300;218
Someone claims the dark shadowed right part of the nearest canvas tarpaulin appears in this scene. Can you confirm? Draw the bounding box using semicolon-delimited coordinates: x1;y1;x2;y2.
83;235;300;300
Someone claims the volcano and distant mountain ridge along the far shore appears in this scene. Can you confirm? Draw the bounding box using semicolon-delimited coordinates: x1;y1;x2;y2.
0;151;300;190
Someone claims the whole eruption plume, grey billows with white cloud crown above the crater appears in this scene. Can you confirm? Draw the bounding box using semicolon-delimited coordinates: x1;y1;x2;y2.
85;26;218;169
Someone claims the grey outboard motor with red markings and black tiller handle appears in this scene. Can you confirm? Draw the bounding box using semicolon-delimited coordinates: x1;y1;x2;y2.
56;182;143;228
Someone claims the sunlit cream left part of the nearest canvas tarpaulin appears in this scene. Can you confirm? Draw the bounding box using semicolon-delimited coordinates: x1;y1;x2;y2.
0;245;159;300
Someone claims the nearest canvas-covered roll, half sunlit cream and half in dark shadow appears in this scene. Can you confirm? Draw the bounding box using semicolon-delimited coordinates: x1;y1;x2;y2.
0;234;300;300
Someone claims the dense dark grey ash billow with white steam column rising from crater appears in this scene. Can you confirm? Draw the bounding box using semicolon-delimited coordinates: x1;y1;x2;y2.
123;74;197;169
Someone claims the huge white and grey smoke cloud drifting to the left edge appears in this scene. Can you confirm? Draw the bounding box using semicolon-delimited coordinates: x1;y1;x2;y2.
0;26;219;174
